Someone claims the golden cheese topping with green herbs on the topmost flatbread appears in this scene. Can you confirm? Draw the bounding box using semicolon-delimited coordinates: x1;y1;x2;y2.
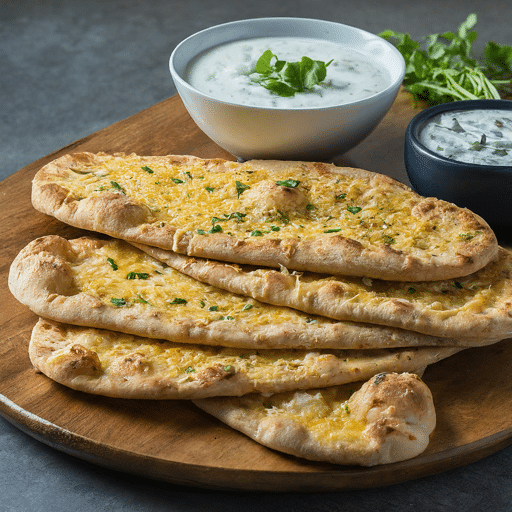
52;151;484;254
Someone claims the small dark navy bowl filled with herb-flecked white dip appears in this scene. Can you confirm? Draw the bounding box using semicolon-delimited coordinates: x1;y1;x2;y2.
404;100;512;229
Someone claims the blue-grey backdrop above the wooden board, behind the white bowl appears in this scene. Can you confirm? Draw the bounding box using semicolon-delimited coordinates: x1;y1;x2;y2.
0;0;512;179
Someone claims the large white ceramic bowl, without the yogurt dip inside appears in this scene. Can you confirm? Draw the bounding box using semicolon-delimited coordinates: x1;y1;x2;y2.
169;18;405;160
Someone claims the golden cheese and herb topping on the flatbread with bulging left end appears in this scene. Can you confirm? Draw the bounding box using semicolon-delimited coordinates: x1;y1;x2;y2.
70;240;333;325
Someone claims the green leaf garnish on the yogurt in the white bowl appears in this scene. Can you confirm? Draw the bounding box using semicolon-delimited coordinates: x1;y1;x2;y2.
253;50;332;97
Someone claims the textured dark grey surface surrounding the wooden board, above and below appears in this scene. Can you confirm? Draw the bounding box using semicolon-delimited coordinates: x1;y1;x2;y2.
0;0;512;512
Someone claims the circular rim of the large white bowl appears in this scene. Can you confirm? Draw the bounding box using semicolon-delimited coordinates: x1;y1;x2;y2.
169;16;406;112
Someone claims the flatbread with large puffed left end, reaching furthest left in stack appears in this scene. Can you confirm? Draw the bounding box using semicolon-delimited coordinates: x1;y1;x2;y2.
9;235;464;349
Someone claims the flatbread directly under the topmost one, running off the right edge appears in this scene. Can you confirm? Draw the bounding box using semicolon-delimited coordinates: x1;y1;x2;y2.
136;244;512;346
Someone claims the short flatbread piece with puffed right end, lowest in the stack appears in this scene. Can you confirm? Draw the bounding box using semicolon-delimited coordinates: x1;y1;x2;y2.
194;373;436;466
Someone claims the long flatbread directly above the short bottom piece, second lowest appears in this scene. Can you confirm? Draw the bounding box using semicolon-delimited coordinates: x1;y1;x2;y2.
29;319;457;399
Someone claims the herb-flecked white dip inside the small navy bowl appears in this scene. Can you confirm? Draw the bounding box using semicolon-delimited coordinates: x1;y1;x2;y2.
418;109;512;166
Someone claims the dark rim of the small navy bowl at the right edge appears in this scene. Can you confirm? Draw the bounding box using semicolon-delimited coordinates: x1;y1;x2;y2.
405;99;512;173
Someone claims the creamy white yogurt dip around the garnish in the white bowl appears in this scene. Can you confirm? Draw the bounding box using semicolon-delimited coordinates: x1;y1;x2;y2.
184;37;391;109
